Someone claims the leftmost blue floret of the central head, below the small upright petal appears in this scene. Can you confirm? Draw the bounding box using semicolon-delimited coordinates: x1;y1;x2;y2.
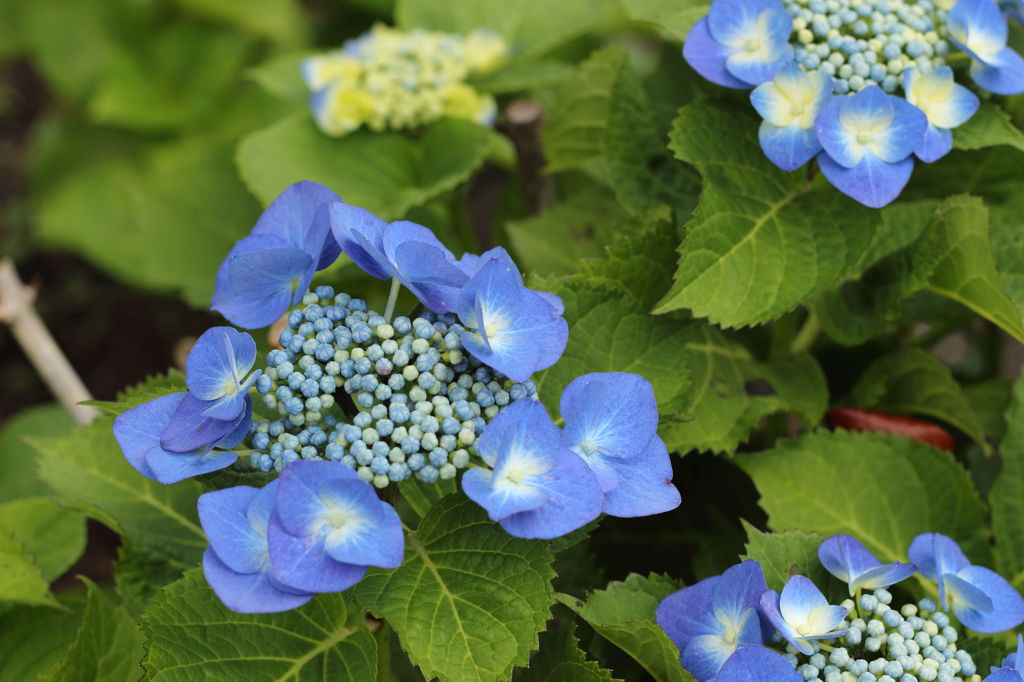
114;393;243;484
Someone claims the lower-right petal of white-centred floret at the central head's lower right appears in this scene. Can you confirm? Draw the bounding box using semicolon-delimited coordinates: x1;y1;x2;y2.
499;450;603;540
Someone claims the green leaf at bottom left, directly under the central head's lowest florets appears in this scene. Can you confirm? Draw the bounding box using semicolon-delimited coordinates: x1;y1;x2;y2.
142;568;377;682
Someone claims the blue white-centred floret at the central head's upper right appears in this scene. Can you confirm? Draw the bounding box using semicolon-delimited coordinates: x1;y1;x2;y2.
458;258;568;381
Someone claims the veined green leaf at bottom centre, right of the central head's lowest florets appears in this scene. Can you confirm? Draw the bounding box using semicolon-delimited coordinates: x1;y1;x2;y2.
352;496;554;682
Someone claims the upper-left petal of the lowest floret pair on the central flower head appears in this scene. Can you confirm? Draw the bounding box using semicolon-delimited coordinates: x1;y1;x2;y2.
197;485;272;573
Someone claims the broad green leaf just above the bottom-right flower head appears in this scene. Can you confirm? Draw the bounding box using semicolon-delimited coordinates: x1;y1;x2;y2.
736;431;988;563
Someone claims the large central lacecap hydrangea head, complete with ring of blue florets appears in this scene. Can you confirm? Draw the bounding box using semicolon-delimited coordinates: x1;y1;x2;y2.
114;182;680;612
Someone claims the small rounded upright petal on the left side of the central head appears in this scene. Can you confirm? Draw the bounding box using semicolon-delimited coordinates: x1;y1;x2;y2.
185;327;256;399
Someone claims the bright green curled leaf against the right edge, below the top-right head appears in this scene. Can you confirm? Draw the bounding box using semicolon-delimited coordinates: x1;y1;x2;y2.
922;196;1024;342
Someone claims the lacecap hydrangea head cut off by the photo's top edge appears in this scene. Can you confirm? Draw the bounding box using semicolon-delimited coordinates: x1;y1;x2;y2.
683;0;1024;208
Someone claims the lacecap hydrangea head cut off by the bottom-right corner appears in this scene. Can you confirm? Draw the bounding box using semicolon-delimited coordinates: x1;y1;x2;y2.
655;534;1024;682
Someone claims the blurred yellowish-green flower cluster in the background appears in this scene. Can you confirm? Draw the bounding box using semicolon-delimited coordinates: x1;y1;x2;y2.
302;25;508;136
